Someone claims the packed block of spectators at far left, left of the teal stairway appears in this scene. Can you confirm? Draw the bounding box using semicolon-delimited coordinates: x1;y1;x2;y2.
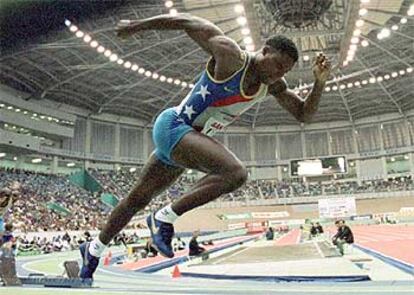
0;169;109;232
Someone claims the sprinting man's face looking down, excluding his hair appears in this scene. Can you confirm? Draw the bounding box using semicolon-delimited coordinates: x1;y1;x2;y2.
258;46;295;85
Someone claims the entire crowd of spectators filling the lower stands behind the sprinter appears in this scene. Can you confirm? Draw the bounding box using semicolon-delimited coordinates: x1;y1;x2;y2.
0;168;414;232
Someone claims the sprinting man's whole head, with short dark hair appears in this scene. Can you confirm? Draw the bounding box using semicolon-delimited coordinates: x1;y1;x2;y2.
257;35;299;85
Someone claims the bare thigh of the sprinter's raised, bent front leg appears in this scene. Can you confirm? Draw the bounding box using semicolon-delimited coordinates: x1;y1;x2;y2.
171;131;243;173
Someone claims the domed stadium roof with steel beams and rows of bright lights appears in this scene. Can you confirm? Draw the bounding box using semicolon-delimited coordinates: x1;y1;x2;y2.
0;0;414;127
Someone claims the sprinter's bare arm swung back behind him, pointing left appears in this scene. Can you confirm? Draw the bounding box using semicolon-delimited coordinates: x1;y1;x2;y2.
116;13;240;56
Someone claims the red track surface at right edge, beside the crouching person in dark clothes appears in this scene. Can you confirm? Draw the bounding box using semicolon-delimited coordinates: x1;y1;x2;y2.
352;225;414;265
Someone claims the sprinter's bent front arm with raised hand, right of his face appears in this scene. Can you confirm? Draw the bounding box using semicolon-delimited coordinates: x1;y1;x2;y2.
269;54;331;122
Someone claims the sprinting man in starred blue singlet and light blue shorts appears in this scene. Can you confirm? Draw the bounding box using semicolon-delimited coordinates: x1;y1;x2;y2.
80;14;331;279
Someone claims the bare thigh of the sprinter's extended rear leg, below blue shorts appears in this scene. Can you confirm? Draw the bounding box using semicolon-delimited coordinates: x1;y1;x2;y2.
133;152;184;196
